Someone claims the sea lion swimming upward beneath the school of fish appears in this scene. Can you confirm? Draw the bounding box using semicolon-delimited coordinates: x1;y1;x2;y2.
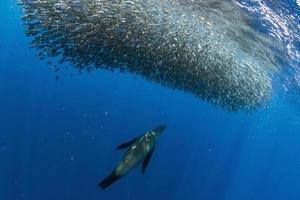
98;125;167;189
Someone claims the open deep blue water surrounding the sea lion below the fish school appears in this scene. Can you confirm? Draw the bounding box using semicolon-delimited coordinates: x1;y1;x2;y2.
0;0;300;200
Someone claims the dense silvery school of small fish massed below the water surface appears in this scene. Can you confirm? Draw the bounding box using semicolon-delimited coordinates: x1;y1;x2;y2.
20;0;272;111
